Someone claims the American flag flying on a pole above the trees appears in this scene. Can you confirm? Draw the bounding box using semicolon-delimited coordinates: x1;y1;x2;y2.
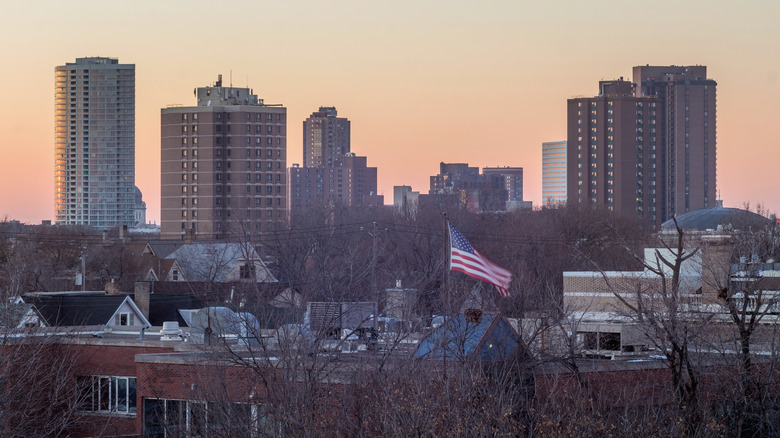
448;224;512;297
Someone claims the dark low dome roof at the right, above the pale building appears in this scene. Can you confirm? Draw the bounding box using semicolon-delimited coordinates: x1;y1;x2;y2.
661;207;772;231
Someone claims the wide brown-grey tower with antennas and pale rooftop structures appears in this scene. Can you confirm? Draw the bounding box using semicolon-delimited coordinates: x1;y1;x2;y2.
161;75;287;240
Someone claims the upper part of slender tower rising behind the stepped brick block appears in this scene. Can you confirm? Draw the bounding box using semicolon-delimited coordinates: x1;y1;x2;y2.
303;106;350;167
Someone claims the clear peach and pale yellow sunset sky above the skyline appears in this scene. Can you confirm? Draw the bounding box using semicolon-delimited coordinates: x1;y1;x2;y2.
0;0;780;223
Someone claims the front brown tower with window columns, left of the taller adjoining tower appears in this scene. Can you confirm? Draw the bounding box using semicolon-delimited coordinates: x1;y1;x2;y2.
566;78;665;226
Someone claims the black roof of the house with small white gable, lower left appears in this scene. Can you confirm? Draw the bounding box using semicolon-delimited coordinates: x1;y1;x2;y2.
24;293;148;326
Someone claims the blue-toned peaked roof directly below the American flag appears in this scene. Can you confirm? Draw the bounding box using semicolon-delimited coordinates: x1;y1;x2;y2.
414;314;520;361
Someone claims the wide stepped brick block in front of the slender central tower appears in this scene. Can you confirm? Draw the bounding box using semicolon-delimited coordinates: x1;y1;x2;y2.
288;153;384;216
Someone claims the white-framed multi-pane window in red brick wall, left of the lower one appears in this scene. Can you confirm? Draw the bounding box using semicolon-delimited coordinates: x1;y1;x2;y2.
76;376;136;415
